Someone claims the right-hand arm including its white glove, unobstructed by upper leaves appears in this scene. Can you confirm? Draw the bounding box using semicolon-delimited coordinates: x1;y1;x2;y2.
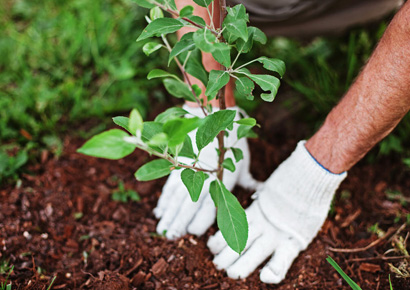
208;3;410;283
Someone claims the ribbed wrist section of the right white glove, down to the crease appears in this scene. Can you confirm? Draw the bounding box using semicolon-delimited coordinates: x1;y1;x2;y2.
258;141;347;248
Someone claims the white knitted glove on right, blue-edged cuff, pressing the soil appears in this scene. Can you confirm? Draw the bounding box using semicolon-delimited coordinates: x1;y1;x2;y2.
208;141;347;283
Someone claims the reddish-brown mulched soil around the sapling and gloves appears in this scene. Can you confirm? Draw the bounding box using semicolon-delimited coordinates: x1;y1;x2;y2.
0;99;410;290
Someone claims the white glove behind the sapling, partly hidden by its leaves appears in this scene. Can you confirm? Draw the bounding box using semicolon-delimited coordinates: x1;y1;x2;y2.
154;105;259;239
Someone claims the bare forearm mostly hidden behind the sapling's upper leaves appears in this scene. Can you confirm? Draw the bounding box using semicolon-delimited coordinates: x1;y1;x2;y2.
175;0;235;107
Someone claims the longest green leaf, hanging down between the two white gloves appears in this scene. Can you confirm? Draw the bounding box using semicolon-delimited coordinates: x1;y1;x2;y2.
209;180;248;254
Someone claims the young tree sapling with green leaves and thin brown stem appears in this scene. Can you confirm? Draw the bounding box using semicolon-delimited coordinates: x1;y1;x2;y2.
78;0;285;253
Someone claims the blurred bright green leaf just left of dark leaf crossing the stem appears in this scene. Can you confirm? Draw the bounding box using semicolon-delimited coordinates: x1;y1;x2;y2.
163;117;202;147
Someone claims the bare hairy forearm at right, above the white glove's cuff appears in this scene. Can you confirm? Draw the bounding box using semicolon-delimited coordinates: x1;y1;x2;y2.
306;2;410;173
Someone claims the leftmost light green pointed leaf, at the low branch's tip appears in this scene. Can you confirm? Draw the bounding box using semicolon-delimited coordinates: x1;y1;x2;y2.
77;129;136;159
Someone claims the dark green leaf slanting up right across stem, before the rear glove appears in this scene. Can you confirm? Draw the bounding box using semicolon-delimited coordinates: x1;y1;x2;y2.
196;110;236;151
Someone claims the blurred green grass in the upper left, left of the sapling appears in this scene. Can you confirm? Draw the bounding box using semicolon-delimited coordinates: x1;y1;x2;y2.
0;0;167;182
